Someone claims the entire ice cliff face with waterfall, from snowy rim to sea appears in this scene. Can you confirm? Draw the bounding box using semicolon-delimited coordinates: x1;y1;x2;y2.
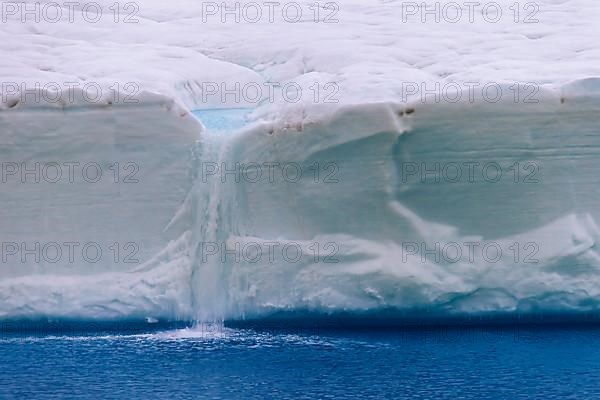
0;80;600;328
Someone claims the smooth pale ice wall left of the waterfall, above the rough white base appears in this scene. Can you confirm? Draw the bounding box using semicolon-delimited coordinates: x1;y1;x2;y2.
0;87;203;279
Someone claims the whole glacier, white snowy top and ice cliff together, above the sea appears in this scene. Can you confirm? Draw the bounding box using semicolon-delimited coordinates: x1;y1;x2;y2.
0;0;600;320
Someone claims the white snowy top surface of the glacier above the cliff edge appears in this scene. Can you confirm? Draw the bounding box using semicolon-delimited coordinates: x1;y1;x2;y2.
0;0;600;116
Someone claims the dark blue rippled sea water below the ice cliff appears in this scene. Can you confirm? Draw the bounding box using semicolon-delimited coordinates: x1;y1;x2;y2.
0;327;600;400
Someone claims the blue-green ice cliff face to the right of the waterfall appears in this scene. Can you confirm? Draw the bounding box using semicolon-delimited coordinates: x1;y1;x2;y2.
210;96;600;322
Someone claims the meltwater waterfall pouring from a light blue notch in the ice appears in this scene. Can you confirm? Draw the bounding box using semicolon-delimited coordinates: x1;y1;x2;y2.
191;109;248;324
